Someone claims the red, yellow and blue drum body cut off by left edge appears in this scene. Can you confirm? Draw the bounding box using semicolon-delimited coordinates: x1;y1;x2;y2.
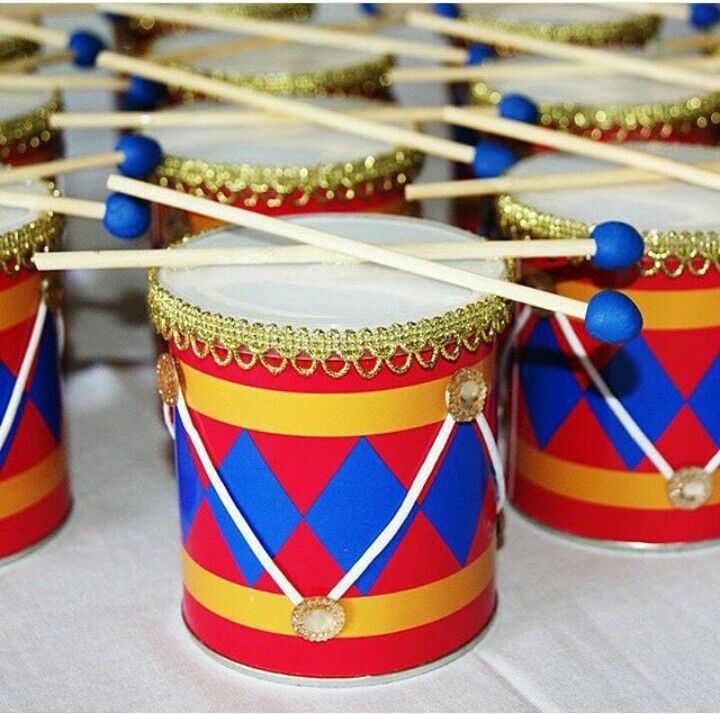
0;270;70;559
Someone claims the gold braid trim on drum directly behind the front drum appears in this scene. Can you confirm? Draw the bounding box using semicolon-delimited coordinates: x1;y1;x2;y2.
155;148;424;208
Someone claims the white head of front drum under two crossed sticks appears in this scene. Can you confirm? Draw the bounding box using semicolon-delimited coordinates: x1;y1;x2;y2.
158;213;505;330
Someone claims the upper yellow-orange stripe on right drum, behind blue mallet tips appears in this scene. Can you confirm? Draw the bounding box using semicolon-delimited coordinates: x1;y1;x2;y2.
557;281;720;330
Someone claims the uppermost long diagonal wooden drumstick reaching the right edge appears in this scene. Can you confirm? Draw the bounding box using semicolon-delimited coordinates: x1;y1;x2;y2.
407;11;720;91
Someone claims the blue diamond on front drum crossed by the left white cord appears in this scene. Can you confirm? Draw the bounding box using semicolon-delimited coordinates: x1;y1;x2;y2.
207;432;301;585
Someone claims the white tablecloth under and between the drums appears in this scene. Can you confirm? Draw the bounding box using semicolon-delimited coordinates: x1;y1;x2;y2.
0;6;720;711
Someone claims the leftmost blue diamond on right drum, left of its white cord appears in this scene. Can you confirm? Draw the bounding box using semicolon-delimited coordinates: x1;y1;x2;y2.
520;320;582;448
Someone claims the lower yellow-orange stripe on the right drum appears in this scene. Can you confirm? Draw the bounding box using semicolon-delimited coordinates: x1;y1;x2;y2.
517;440;720;511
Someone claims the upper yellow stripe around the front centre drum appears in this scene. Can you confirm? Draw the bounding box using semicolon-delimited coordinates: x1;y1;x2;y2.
180;351;495;436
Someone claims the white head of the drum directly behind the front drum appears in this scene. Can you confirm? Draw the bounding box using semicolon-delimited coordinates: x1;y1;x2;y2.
145;98;402;166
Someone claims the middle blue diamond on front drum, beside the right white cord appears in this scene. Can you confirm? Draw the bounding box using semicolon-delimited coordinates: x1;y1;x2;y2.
306;438;405;593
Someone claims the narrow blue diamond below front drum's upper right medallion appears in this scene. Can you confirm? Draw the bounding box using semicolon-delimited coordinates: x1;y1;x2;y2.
422;424;489;565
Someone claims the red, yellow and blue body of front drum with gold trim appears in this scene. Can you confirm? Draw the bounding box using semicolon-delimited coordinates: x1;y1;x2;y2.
149;217;509;681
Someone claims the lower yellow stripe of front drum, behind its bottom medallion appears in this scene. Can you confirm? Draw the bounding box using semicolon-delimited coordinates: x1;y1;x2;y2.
182;543;495;637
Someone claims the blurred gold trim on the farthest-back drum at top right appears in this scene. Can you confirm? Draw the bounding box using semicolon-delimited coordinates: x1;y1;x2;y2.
467;14;660;46
